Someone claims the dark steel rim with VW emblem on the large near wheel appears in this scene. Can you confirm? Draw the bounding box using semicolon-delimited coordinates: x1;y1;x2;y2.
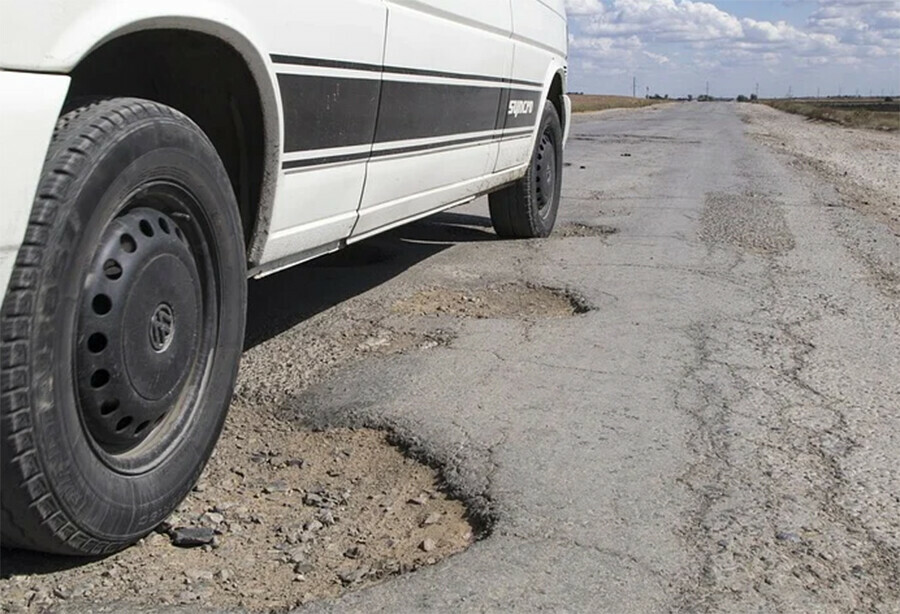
72;181;220;474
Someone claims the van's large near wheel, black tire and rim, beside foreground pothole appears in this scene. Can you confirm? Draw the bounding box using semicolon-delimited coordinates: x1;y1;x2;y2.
0;98;247;555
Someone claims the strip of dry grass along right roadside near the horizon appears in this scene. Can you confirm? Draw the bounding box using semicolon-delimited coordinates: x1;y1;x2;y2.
763;98;900;130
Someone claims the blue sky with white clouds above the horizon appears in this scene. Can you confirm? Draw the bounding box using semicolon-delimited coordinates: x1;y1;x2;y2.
566;0;900;98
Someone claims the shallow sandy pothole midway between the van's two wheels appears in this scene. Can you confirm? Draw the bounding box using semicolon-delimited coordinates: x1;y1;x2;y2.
393;283;591;319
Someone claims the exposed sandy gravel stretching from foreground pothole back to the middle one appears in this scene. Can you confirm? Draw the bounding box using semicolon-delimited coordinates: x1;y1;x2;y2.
0;280;587;612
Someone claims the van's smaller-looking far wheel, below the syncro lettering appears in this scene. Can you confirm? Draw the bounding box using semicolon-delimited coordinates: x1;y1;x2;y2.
489;101;563;239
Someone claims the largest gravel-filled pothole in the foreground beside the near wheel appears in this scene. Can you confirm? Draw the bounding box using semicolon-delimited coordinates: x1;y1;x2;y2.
0;416;477;612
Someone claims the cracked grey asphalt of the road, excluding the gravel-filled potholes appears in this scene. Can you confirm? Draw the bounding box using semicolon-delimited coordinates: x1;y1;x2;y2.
284;103;900;612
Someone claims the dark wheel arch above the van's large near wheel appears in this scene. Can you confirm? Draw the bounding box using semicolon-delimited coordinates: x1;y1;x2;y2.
54;16;283;266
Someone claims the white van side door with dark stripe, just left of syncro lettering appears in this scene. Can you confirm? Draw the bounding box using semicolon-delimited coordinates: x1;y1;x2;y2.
354;0;513;237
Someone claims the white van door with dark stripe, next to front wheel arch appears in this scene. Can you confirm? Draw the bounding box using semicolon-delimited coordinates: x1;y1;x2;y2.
254;0;387;266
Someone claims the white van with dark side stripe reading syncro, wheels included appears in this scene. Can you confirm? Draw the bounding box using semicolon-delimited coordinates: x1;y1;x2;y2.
0;0;570;555
